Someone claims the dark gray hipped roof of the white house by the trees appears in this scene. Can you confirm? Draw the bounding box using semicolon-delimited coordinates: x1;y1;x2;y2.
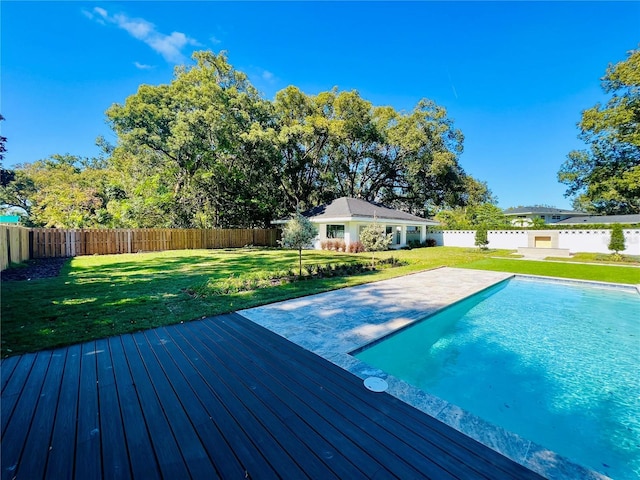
302;197;438;225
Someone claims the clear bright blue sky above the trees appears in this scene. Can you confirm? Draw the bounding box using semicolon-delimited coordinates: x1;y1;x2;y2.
0;0;640;208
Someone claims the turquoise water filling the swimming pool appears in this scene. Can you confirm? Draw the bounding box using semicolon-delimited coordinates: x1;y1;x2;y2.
355;278;640;480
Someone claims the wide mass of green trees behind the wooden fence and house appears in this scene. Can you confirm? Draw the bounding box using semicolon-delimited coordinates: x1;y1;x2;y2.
2;51;495;228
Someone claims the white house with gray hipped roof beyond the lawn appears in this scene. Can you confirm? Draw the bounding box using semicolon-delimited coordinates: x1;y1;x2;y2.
273;197;438;249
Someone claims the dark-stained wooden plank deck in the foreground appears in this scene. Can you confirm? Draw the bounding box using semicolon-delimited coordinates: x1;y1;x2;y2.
1;314;542;480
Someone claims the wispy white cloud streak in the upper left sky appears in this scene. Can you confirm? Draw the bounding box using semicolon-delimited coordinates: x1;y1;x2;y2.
83;7;200;63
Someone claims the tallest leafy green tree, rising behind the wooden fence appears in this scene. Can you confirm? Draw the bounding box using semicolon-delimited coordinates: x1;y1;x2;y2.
107;51;282;228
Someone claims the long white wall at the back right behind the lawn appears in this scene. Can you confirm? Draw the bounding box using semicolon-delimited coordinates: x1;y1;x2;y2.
427;229;640;255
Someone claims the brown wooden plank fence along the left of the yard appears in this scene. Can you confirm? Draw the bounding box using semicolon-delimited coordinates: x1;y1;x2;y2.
0;226;281;270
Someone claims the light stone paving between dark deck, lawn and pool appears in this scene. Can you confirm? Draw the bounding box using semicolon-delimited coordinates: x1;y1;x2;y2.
238;267;607;480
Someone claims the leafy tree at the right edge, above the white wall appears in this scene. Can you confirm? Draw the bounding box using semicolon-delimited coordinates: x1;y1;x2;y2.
558;49;640;214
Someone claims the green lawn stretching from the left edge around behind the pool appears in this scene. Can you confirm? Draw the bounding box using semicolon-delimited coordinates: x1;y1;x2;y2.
1;247;640;357
